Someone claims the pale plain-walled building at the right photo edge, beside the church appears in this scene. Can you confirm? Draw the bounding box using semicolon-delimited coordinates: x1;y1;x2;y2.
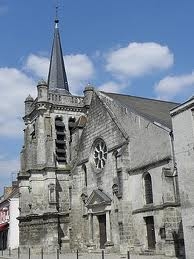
171;97;194;259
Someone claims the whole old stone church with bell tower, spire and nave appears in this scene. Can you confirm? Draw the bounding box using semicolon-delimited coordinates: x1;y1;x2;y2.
18;20;184;259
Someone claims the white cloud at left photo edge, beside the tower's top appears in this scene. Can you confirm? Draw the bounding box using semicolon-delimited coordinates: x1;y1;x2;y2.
0;68;36;137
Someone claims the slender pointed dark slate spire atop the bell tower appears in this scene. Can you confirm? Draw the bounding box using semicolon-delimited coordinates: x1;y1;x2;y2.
48;18;70;94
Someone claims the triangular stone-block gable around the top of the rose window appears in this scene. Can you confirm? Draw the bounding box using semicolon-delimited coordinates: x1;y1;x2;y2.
78;92;128;164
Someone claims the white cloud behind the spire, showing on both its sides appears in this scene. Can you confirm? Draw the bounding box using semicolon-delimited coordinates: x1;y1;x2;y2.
24;54;95;94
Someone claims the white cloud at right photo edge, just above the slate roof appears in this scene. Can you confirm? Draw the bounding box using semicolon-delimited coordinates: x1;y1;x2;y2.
155;72;194;99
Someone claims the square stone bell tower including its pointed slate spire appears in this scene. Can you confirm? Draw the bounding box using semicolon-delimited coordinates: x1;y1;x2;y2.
18;13;88;252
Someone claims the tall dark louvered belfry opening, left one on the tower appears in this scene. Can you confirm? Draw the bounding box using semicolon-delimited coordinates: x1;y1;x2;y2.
55;117;67;163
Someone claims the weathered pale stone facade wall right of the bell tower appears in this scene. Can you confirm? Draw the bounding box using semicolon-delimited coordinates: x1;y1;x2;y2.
71;93;180;256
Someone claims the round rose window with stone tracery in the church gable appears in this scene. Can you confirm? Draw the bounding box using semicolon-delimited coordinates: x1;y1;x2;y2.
94;140;107;169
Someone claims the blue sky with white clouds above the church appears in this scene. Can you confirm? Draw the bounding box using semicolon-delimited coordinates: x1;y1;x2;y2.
0;0;194;193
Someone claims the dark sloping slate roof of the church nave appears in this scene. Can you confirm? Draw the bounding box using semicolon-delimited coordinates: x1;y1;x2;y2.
103;92;179;129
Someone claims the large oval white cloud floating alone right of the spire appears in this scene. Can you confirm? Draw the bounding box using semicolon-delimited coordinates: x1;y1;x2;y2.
106;42;174;78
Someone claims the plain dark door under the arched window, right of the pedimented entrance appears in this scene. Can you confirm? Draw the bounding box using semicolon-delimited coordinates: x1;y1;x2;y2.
145;217;156;249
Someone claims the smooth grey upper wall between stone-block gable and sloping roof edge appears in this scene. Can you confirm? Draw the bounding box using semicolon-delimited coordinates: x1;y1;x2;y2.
99;93;171;169
